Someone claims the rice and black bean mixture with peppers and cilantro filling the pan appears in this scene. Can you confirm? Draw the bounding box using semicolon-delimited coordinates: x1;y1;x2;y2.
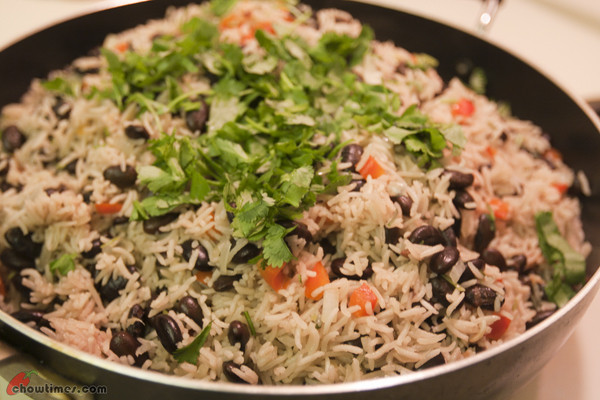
0;0;590;384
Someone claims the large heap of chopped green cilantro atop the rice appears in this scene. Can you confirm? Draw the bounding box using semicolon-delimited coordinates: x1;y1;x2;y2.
98;0;464;267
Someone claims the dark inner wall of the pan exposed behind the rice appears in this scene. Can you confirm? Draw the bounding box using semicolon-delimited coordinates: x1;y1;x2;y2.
0;0;600;398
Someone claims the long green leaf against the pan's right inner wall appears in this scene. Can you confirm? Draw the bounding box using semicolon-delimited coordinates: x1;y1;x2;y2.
535;211;585;307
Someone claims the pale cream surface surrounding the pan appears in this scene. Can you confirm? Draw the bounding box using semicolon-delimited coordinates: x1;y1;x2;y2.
0;0;600;400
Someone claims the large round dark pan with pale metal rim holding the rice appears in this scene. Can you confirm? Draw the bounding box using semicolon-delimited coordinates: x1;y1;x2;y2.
0;0;600;399
